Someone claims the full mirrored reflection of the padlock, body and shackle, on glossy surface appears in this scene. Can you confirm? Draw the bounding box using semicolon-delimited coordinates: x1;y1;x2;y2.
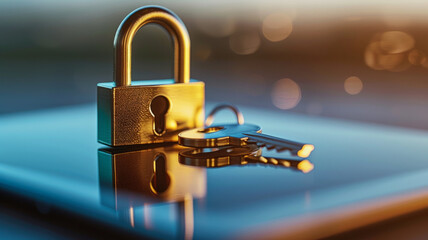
98;144;207;239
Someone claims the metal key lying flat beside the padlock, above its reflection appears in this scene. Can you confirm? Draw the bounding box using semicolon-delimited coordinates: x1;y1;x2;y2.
178;123;314;158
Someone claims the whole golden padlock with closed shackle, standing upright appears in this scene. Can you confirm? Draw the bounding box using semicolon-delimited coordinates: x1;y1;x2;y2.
97;6;205;146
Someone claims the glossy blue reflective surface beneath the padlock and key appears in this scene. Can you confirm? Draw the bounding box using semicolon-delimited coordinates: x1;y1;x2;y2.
0;105;428;238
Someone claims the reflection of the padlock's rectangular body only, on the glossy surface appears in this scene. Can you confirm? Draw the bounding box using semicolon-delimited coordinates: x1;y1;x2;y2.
98;145;206;209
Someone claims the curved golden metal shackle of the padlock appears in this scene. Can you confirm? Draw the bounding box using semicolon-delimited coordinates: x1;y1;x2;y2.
114;6;190;87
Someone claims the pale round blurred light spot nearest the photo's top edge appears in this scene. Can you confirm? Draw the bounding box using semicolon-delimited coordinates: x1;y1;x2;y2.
262;13;293;42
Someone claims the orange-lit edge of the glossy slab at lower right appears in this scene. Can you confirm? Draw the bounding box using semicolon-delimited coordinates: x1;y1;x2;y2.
237;183;428;239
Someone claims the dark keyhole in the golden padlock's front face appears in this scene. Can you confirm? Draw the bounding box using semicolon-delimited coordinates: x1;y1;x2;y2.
150;96;170;136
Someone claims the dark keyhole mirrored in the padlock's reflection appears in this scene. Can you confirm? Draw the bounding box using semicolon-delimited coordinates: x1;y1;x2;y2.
151;154;171;194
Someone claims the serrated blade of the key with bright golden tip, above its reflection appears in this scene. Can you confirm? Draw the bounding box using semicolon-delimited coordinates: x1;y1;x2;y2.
243;133;315;158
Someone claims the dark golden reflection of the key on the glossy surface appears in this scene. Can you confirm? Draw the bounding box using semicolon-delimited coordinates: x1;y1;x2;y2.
179;144;314;173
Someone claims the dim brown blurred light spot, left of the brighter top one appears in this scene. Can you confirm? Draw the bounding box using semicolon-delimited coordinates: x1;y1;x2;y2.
229;31;260;55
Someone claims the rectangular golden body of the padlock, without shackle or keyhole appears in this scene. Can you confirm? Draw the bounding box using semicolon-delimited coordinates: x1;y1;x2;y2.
97;79;205;146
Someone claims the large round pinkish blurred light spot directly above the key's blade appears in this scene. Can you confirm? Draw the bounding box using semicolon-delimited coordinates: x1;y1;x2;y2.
271;78;302;110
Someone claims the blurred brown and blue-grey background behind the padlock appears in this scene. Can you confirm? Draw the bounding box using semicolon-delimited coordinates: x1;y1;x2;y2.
0;0;428;129
